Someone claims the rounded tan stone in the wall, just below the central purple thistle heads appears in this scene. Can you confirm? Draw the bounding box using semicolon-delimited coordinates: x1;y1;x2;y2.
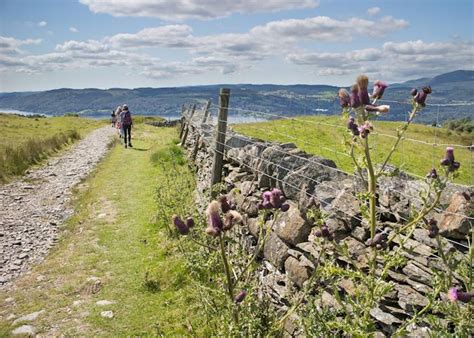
275;201;312;246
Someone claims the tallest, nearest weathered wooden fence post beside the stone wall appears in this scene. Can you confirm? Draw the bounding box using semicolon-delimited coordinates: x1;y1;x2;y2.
211;88;230;187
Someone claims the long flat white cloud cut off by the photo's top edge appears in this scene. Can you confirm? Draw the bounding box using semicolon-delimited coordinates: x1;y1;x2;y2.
79;0;319;21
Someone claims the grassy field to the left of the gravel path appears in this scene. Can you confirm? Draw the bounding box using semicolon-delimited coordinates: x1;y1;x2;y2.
0;113;104;182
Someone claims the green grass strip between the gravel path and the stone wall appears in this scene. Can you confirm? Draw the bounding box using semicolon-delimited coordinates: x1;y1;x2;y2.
0;125;204;336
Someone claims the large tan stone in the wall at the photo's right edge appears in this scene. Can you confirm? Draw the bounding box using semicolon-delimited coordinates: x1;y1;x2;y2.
438;192;474;239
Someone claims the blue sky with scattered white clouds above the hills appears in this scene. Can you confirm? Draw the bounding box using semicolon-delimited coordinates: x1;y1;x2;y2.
0;0;474;92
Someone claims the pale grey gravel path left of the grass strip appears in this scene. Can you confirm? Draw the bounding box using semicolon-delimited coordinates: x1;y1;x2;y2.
0;127;116;288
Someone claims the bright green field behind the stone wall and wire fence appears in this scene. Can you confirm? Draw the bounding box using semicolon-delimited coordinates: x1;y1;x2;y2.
233;116;474;185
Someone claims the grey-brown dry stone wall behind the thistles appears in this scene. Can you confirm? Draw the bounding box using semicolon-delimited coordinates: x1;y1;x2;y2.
178;118;473;336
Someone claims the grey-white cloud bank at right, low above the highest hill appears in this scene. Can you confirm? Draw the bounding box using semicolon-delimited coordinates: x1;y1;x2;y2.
286;40;474;80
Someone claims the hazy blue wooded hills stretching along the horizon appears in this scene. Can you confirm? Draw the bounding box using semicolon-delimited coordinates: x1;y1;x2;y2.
0;70;474;123
